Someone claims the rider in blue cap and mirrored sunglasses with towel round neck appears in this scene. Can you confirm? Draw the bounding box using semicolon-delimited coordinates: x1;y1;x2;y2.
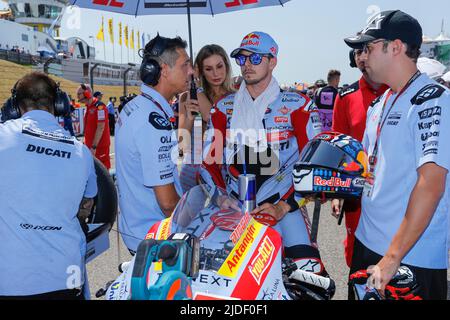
202;32;325;273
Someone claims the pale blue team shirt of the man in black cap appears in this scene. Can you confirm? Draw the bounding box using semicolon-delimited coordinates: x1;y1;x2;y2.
356;74;450;269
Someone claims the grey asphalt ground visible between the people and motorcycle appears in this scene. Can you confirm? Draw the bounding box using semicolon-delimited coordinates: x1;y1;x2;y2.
87;138;450;300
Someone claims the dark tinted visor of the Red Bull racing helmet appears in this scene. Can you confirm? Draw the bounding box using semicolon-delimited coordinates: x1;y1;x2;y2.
299;140;365;174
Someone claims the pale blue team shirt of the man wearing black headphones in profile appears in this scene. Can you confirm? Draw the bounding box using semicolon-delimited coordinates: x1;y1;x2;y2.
115;85;182;251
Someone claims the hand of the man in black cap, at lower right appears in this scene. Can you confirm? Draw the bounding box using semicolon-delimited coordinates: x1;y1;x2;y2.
367;256;401;299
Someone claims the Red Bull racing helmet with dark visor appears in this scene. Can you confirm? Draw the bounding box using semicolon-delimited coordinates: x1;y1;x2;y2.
293;132;369;199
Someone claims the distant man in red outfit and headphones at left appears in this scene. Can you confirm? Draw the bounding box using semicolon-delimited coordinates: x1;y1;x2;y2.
77;84;111;169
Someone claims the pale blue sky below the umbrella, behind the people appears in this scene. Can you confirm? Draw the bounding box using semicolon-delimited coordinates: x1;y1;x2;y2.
3;0;450;84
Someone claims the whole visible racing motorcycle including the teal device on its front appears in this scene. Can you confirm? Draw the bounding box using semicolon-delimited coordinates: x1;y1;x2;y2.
106;185;335;300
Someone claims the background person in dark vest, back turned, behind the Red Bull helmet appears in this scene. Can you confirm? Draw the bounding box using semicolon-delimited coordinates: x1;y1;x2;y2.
314;70;341;131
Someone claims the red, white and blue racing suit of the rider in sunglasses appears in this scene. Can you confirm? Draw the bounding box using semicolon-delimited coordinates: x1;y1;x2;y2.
201;91;325;274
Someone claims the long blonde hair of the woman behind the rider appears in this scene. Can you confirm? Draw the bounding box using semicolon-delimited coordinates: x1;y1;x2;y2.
195;44;235;102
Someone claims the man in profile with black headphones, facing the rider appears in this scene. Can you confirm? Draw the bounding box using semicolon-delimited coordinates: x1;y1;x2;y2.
115;35;193;251
